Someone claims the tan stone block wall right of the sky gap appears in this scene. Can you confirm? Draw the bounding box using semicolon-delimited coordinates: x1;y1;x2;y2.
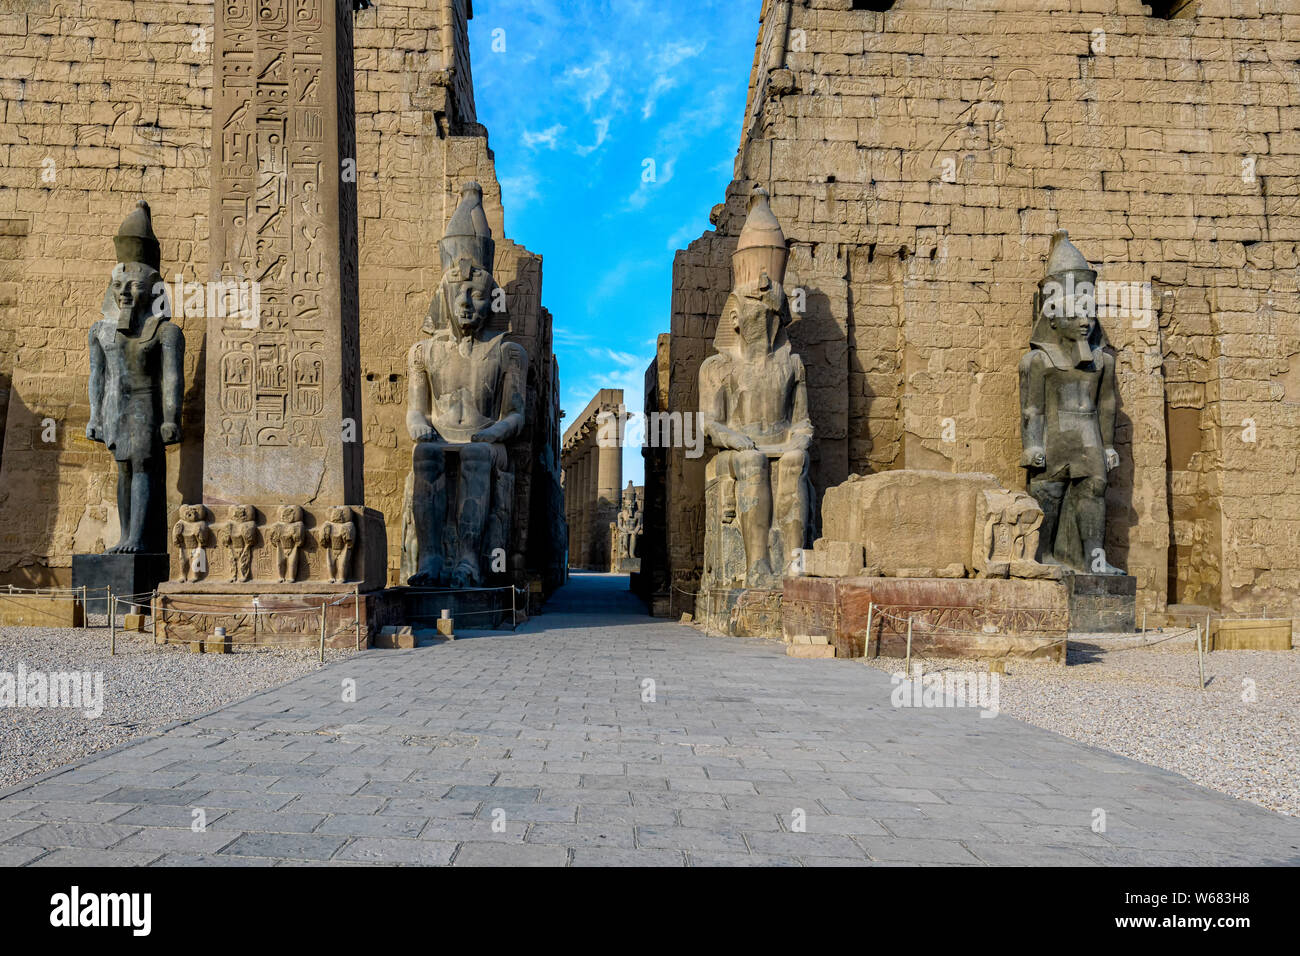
660;0;1300;613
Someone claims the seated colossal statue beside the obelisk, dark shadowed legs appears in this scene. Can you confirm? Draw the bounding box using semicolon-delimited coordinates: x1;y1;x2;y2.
403;182;528;588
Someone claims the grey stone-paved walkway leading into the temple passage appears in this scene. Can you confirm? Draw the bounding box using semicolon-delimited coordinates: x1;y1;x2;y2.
0;575;1300;866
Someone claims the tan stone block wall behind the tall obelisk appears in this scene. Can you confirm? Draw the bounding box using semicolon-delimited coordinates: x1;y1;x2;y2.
0;0;558;583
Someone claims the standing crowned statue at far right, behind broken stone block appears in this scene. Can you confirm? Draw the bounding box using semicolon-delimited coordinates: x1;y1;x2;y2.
1021;230;1123;575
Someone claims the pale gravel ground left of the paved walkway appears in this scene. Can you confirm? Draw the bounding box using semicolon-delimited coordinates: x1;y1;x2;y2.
0;615;335;788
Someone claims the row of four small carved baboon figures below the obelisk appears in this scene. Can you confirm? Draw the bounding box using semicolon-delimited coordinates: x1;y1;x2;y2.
172;505;356;584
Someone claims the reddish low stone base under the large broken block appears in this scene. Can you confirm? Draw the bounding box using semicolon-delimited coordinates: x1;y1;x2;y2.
781;578;1070;663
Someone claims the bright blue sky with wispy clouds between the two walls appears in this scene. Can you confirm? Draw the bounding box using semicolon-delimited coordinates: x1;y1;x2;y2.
469;0;761;484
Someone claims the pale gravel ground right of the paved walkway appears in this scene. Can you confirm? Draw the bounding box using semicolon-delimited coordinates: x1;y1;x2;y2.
867;631;1300;816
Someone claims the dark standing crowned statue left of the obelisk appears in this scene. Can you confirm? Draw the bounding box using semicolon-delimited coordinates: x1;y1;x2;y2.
86;199;185;554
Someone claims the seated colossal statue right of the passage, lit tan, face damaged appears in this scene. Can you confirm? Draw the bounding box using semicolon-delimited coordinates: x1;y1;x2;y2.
699;189;813;588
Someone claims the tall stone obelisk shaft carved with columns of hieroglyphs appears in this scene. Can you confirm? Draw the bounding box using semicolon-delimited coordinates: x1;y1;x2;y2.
203;0;361;506
